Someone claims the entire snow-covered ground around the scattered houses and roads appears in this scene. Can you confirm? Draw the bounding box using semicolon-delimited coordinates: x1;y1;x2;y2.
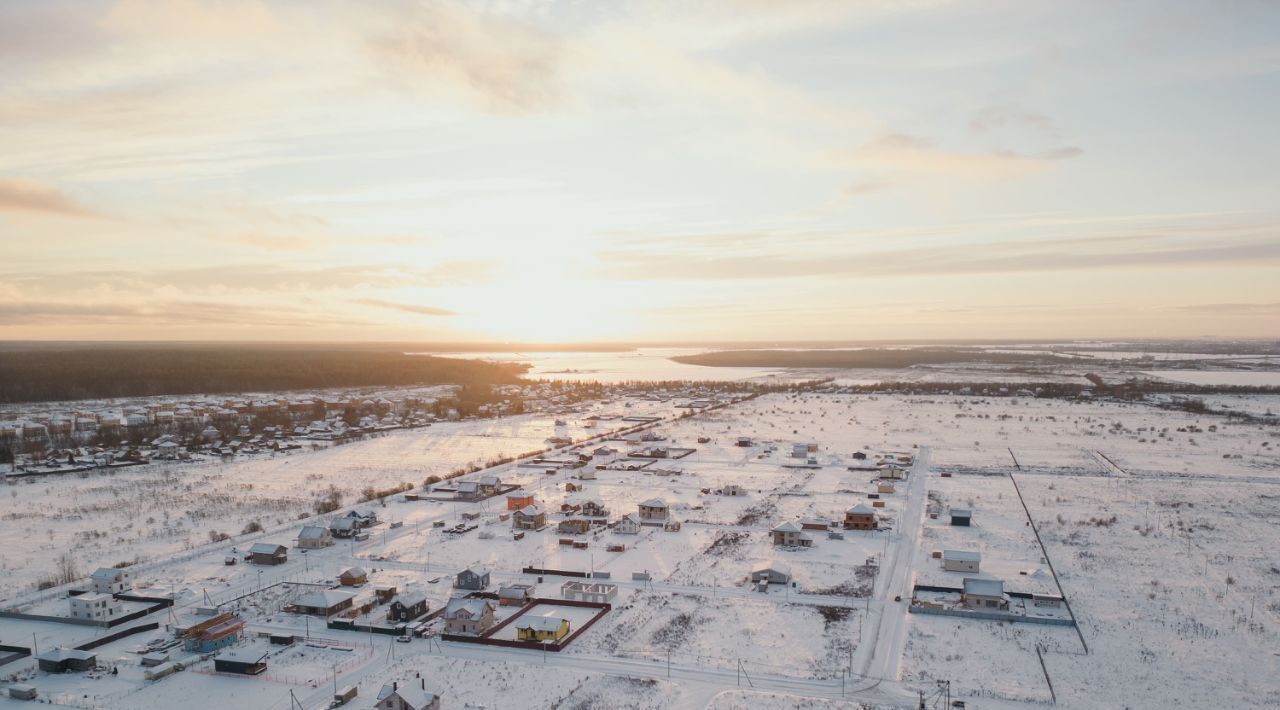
0;394;1280;707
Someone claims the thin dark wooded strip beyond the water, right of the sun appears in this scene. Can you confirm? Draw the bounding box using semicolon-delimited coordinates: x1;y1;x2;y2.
671;348;1078;370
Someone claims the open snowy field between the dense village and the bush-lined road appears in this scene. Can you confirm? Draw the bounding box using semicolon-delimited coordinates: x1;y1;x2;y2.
0;400;671;603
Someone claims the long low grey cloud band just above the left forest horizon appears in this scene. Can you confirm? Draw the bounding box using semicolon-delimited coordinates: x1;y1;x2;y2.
0;301;369;327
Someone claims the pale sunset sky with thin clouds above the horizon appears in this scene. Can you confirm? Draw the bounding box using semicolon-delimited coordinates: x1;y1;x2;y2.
0;0;1280;342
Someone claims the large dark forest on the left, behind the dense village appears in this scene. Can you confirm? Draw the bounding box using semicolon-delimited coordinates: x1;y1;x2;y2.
0;344;526;403
